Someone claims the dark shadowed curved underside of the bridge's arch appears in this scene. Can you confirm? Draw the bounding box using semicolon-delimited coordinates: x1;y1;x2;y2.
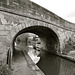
12;25;60;53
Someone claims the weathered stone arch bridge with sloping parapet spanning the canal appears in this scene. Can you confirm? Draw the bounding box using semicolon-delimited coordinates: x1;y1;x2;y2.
0;0;75;67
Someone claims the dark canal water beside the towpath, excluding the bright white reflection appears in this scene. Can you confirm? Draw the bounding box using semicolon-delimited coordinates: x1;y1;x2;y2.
37;52;75;75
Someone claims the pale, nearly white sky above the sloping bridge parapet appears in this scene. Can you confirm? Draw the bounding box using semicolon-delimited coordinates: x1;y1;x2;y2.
30;0;75;23
